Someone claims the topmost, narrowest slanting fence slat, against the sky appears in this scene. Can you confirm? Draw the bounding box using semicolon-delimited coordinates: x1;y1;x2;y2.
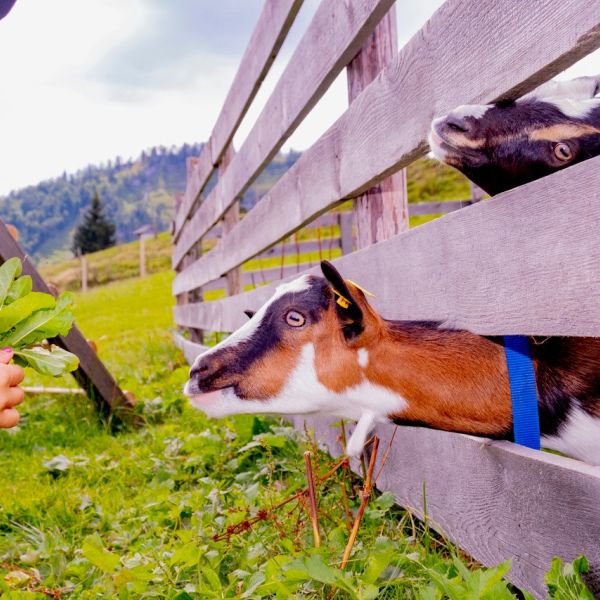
174;0;303;239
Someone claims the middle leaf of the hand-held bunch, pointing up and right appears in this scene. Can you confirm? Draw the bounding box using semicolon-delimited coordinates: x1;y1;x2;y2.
0;294;73;348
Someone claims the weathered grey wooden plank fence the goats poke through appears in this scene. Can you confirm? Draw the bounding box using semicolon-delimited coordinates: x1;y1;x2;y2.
173;0;600;597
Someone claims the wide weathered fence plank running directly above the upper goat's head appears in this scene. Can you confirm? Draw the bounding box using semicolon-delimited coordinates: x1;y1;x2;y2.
176;0;600;285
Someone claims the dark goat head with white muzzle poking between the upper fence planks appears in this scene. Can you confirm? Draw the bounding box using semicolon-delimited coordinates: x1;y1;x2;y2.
429;76;600;195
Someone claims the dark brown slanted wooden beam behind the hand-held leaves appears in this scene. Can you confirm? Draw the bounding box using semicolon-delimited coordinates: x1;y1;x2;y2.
0;221;132;411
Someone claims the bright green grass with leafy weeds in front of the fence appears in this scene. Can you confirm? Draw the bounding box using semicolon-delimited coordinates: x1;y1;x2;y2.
0;273;586;600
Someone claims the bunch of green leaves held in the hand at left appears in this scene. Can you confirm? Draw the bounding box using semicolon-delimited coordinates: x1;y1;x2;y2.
0;258;79;376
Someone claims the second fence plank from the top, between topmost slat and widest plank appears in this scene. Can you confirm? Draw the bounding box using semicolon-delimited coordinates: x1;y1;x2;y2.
173;0;394;267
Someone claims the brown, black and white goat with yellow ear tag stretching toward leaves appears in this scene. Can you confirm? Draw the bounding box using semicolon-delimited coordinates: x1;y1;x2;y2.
185;261;600;464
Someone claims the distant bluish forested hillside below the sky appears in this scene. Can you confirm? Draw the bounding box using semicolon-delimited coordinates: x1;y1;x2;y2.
0;144;298;259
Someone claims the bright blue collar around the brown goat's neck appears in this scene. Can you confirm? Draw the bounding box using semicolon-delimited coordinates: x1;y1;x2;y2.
504;335;541;450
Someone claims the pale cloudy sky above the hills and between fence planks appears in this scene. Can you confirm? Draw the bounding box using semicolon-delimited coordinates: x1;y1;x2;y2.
0;0;600;195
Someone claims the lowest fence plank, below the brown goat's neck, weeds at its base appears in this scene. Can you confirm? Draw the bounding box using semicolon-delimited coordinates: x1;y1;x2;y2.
294;417;600;598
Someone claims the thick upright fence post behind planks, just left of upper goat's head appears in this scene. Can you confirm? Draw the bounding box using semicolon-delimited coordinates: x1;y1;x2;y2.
346;7;408;249
